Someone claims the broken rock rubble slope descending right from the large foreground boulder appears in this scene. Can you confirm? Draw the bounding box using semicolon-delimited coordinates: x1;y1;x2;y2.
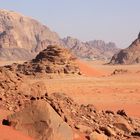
46;93;140;140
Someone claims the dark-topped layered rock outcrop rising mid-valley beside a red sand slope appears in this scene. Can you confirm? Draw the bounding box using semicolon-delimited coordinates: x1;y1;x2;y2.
4;45;80;75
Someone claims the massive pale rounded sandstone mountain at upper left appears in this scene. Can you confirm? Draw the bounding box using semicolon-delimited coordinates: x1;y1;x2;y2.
0;10;60;60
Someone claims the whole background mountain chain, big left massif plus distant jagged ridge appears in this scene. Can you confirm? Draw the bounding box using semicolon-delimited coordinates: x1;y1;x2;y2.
0;10;119;60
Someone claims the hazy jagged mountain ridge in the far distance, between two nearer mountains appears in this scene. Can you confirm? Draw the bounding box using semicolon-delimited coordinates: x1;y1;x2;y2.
63;37;119;60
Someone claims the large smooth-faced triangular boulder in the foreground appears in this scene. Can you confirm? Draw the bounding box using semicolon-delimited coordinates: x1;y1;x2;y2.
8;101;73;140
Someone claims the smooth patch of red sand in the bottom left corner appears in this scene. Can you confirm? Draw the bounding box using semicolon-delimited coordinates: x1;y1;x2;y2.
0;125;33;140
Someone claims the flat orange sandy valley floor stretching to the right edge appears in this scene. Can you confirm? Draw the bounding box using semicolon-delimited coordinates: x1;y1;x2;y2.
1;61;140;117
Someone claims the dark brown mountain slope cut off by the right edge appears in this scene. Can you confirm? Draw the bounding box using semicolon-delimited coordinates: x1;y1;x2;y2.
110;33;140;64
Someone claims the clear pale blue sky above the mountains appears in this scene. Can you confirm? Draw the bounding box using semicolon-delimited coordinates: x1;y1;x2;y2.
0;0;140;48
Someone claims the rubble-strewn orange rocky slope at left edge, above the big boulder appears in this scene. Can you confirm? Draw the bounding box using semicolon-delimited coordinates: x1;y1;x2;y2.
0;68;47;112
